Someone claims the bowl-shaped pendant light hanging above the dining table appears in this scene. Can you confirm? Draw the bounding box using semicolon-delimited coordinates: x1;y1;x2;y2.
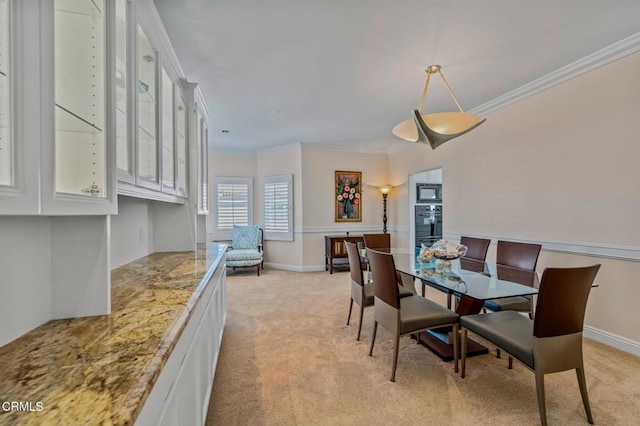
392;65;485;149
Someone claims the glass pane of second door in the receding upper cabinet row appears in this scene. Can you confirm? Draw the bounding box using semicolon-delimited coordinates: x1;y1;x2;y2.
136;26;160;189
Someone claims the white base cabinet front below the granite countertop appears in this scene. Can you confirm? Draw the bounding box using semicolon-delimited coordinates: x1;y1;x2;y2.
136;259;226;426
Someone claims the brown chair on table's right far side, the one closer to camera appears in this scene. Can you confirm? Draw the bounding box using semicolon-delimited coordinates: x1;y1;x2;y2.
484;241;542;317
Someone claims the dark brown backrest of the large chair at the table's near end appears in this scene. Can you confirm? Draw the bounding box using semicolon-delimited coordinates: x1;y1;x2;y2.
533;265;600;337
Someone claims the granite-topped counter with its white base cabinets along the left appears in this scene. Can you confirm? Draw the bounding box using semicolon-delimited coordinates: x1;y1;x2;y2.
0;243;226;425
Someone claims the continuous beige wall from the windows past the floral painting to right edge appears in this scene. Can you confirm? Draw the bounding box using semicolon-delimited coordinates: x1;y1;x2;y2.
210;54;640;345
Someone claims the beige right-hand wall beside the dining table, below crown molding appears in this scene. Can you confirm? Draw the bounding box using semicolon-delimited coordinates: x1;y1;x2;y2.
389;50;640;341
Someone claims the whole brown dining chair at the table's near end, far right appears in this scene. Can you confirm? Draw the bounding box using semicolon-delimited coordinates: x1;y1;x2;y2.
460;265;600;426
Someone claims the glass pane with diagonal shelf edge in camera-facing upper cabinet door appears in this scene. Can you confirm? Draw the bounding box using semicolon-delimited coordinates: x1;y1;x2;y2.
54;0;107;198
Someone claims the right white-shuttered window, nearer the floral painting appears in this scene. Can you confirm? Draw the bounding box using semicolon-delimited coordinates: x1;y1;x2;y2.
262;175;293;241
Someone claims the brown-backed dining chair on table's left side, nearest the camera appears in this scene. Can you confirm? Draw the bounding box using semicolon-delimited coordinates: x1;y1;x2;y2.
367;249;459;382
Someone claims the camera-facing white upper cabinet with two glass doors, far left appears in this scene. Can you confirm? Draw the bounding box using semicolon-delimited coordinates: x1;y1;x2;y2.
0;0;115;215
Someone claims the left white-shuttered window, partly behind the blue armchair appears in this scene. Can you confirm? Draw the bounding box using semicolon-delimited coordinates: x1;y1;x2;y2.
213;177;253;241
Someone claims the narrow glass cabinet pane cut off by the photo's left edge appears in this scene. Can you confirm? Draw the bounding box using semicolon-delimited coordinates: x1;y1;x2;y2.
0;0;14;187
